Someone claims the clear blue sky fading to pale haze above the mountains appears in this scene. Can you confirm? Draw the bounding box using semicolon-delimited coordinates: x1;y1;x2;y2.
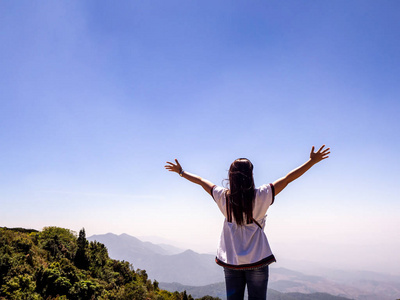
0;0;400;273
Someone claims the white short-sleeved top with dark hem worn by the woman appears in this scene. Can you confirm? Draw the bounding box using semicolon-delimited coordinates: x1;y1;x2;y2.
212;184;276;269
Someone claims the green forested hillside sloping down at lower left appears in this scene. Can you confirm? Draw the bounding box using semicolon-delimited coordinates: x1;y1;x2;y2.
0;227;219;300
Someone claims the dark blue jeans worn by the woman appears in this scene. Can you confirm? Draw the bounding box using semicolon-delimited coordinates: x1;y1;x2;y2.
224;266;269;300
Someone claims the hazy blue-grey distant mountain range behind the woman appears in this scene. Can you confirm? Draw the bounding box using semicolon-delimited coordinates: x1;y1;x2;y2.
88;233;400;300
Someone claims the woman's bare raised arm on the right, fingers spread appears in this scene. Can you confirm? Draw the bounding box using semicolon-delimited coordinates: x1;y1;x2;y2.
273;145;331;195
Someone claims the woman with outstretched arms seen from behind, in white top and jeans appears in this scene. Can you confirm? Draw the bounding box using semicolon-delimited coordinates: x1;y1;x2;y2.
165;145;330;300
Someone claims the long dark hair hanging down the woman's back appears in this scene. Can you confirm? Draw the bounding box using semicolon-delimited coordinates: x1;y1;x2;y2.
226;158;255;225
